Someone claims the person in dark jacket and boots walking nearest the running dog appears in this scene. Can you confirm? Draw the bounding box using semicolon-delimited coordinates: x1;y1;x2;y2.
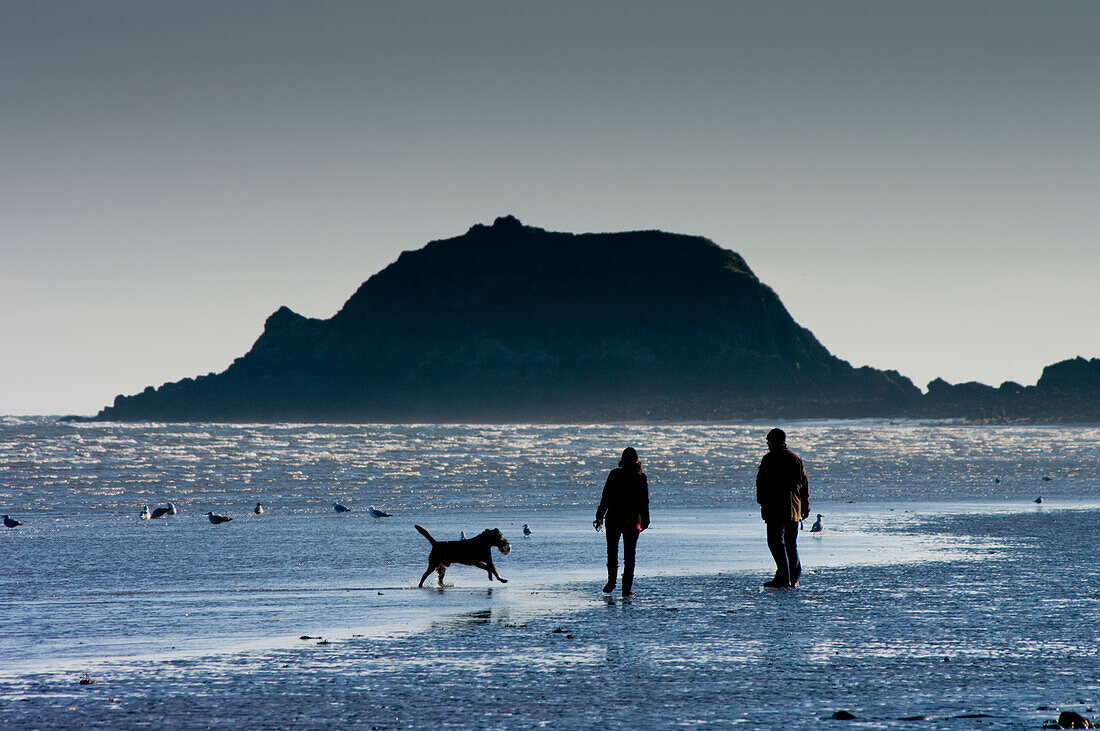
592;446;649;597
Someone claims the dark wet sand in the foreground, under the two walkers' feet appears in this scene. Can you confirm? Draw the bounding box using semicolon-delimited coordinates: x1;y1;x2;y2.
0;506;1100;729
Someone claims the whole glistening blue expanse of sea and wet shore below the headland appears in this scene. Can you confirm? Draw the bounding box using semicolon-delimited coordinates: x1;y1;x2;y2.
0;417;1100;730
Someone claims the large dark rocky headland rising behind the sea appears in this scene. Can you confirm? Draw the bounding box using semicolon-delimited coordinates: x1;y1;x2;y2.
96;217;1100;422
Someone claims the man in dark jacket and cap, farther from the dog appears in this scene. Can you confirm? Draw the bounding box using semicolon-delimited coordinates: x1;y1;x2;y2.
757;429;810;588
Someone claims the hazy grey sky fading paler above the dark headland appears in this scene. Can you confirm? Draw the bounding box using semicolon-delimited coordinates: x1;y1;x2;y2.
0;0;1100;414
